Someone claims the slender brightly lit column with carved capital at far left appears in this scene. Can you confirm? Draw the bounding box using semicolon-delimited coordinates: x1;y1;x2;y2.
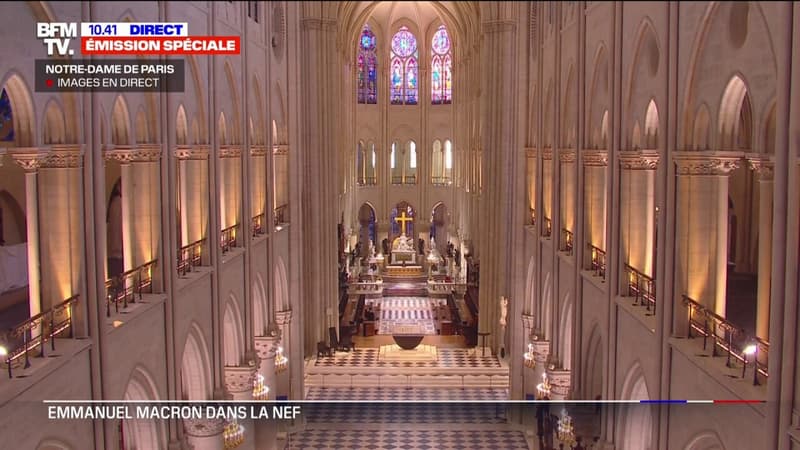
12;148;46;317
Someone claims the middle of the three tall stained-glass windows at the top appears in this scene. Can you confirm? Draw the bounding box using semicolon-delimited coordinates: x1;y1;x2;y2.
389;26;419;105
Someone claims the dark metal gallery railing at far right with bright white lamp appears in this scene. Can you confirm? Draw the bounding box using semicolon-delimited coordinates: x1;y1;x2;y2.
683;295;769;385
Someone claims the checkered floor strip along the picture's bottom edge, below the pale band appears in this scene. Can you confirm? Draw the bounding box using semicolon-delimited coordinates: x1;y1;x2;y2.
286;430;528;450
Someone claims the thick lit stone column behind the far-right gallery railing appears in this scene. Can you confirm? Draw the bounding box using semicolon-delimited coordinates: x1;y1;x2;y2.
674;152;742;318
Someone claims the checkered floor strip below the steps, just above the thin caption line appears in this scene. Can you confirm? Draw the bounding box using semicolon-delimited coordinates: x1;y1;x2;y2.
306;387;508;402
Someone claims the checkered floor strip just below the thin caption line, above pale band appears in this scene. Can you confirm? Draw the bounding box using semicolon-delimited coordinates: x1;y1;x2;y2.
303;403;507;425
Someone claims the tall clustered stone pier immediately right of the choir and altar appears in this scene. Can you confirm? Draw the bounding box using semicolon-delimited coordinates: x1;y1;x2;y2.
478;13;525;353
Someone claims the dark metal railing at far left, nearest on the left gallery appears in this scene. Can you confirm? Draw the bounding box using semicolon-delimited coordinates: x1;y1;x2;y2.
5;295;78;378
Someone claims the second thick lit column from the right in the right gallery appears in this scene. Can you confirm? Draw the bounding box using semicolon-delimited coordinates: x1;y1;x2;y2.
619;150;658;278
